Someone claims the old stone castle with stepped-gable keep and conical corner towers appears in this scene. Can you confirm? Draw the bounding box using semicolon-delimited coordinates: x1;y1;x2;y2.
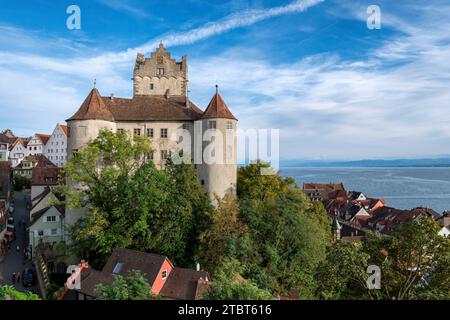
66;43;237;220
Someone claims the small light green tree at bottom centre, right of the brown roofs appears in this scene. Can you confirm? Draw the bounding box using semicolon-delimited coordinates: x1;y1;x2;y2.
202;260;273;300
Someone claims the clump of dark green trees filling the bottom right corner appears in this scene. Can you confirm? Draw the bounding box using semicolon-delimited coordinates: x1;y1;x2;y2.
316;218;450;300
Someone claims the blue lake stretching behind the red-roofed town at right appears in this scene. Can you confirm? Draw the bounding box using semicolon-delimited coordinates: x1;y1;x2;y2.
280;167;450;213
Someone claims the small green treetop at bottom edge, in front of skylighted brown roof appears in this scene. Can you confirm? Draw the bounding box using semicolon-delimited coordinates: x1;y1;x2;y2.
96;271;157;300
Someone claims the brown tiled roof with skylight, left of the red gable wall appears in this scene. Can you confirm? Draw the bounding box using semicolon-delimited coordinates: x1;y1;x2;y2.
102;248;167;285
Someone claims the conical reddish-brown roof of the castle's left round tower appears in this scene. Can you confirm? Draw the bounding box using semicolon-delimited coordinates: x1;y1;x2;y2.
67;88;114;121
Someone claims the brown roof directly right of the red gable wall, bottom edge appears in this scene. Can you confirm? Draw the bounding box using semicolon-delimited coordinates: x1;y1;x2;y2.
160;268;209;300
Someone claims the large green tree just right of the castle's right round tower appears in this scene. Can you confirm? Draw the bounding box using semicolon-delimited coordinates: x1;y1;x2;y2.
237;162;331;298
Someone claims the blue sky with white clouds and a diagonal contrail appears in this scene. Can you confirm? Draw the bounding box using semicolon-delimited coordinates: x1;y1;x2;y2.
0;0;450;160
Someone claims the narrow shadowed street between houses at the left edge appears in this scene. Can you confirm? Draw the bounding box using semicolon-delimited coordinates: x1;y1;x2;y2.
0;192;39;293
